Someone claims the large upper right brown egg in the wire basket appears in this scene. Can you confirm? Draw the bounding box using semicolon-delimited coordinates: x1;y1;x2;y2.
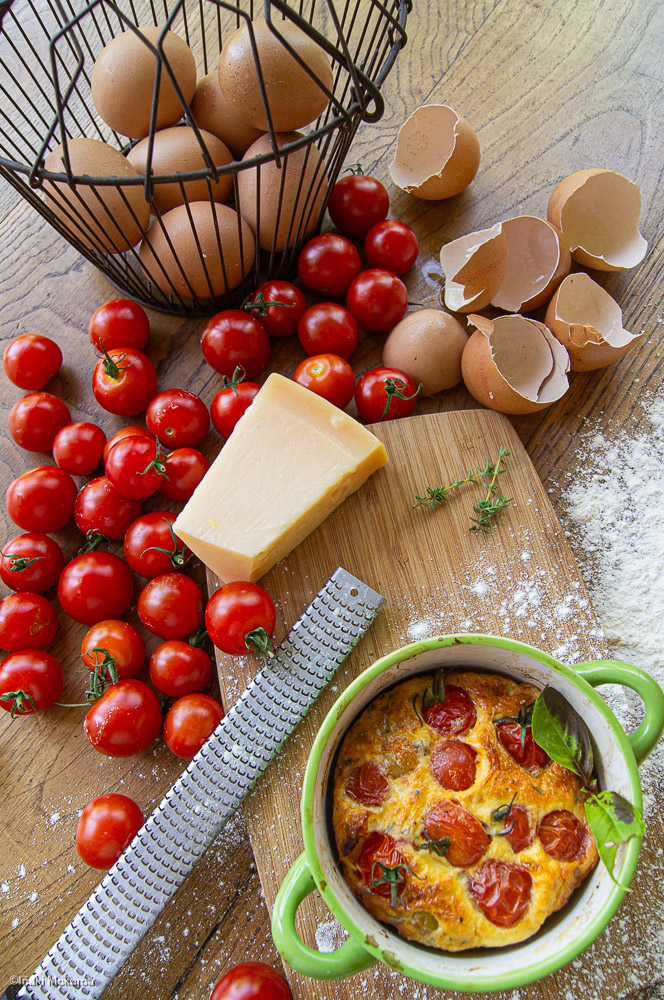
219;20;334;132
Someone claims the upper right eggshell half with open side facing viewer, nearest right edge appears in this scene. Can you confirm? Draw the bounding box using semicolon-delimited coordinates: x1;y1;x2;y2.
547;167;648;271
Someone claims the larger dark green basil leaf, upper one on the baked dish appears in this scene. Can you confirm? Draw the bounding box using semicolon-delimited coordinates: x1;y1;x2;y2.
532;687;594;784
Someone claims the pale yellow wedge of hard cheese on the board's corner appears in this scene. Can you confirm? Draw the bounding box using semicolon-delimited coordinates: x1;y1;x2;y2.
173;373;387;583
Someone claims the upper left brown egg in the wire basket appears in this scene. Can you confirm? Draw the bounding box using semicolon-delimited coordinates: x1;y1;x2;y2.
92;26;196;139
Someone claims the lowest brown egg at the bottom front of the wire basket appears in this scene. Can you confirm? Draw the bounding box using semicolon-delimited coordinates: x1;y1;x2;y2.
139;201;255;299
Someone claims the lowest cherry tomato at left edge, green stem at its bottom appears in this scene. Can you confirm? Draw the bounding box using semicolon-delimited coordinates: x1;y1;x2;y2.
0;649;65;718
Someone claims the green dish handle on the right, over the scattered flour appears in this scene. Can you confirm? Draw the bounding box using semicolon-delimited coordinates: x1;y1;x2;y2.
572;660;664;764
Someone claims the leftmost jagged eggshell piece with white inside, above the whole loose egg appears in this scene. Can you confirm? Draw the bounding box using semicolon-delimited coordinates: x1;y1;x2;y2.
440;222;507;312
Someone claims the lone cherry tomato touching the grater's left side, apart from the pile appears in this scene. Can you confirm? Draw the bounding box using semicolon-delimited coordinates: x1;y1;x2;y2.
75;793;145;871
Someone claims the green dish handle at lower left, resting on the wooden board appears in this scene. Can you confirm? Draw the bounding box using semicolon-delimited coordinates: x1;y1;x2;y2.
272;854;376;979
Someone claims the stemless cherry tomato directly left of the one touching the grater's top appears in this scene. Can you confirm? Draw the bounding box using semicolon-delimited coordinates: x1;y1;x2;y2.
138;573;205;639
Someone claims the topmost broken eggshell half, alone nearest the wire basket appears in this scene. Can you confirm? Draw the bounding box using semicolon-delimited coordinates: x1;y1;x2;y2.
390;104;480;201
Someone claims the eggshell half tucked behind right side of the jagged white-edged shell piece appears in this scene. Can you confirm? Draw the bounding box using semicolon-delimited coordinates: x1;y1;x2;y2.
491;215;572;313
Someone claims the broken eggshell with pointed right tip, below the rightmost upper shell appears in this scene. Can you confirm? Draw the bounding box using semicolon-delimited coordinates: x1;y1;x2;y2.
546;272;642;372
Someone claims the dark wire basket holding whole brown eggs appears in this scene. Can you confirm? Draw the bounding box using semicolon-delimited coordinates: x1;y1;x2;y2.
0;0;411;316
